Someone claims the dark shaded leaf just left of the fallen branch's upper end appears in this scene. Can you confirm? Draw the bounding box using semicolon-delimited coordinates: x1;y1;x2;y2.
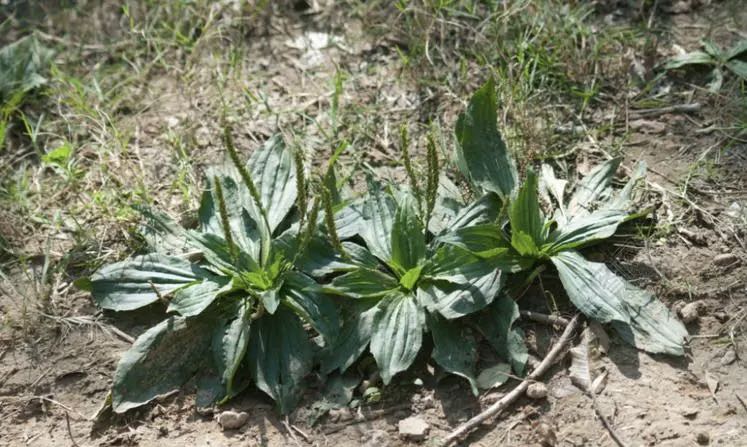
478;294;529;375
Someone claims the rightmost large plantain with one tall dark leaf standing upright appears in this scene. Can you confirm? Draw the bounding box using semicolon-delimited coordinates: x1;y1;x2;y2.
444;82;687;355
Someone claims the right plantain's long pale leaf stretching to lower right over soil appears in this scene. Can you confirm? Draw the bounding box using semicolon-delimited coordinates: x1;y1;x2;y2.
551;250;687;355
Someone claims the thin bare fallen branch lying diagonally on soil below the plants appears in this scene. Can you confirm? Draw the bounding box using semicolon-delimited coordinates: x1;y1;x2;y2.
441;315;581;446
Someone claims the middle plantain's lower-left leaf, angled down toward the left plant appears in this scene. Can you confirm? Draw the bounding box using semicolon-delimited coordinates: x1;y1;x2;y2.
322;299;382;374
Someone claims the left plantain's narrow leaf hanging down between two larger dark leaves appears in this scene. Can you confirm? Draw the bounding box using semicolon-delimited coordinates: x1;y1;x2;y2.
212;298;252;398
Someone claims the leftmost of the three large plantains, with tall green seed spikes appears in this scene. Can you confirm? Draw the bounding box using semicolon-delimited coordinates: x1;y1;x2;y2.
85;130;339;413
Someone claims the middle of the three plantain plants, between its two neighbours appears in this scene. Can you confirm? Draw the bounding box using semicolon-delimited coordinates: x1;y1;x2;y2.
298;132;526;394
